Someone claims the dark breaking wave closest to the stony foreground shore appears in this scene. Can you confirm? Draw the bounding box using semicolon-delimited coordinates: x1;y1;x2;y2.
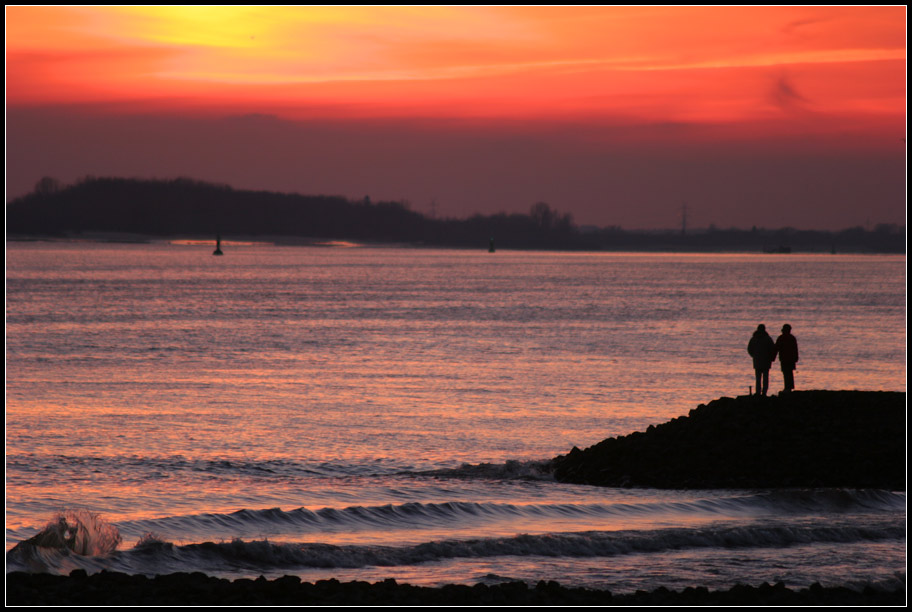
7;522;905;573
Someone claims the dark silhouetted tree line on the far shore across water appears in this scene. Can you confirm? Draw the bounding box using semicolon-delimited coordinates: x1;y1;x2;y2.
6;177;906;253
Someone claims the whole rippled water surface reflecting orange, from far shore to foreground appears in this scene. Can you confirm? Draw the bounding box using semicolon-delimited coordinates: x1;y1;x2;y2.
6;243;905;590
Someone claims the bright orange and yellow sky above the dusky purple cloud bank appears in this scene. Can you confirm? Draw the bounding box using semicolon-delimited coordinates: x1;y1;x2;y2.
6;6;906;122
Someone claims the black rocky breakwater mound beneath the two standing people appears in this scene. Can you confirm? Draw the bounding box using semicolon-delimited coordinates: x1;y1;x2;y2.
552;391;906;491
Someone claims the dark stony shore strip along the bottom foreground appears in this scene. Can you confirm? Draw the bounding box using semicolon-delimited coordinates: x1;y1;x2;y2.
6;570;906;606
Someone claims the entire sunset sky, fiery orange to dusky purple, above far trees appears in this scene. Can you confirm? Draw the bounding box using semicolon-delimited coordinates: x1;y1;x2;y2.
6;6;906;229
